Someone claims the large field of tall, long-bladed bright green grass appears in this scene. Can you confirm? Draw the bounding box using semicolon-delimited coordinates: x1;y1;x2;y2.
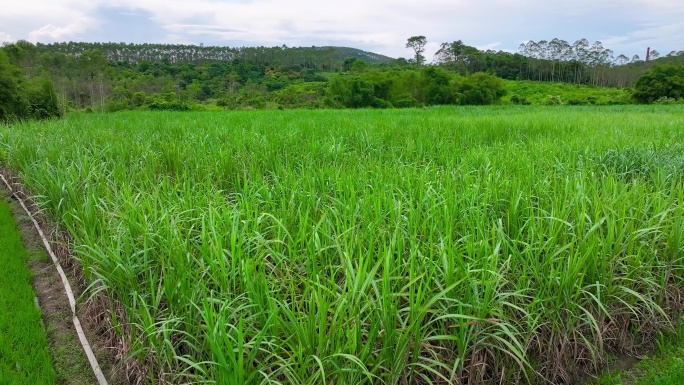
0;106;684;384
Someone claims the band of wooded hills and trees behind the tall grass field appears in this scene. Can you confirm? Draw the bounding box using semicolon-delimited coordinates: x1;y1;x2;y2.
2;36;684;111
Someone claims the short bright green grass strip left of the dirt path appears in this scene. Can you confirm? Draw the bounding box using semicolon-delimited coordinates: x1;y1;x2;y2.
0;198;55;385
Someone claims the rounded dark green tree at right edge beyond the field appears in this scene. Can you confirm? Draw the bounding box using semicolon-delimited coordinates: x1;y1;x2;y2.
634;65;684;103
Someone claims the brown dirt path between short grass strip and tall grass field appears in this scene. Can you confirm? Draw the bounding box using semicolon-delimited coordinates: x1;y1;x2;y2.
0;186;124;385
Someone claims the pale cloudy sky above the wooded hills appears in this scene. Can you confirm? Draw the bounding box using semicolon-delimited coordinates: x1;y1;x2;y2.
0;0;684;58
